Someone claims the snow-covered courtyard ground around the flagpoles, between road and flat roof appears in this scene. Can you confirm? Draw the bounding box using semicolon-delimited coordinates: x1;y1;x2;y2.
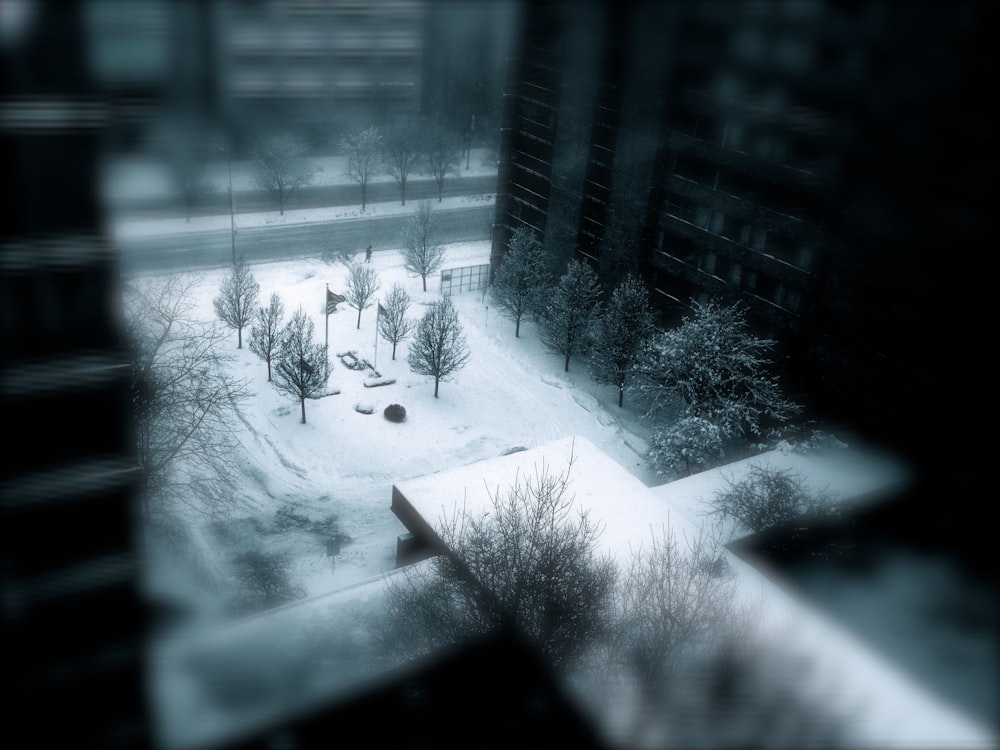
143;242;659;616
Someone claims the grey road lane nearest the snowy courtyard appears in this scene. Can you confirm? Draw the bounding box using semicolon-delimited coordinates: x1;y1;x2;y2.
118;203;494;274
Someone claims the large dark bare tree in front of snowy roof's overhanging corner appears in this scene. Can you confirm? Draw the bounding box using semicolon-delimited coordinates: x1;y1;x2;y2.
388;452;617;667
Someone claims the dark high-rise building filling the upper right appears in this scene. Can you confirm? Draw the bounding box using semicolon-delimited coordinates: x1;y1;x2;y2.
492;0;997;472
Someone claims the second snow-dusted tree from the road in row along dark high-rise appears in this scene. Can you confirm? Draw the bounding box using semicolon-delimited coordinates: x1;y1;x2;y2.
539;260;601;372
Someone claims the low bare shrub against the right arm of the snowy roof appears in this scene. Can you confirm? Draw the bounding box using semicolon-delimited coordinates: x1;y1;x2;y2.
712;466;837;533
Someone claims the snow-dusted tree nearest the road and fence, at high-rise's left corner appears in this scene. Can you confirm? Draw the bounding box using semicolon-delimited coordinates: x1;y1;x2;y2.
490;227;551;337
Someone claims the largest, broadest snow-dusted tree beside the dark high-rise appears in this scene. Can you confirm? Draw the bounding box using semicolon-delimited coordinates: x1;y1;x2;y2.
639;302;799;439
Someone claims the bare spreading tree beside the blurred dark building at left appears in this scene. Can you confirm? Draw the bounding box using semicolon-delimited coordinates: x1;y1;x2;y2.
124;276;250;528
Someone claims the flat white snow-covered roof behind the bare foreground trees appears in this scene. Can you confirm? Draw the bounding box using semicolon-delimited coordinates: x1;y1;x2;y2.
393;436;995;748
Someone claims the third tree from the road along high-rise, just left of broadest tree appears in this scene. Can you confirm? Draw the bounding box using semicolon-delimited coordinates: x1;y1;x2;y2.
590;275;655;408
